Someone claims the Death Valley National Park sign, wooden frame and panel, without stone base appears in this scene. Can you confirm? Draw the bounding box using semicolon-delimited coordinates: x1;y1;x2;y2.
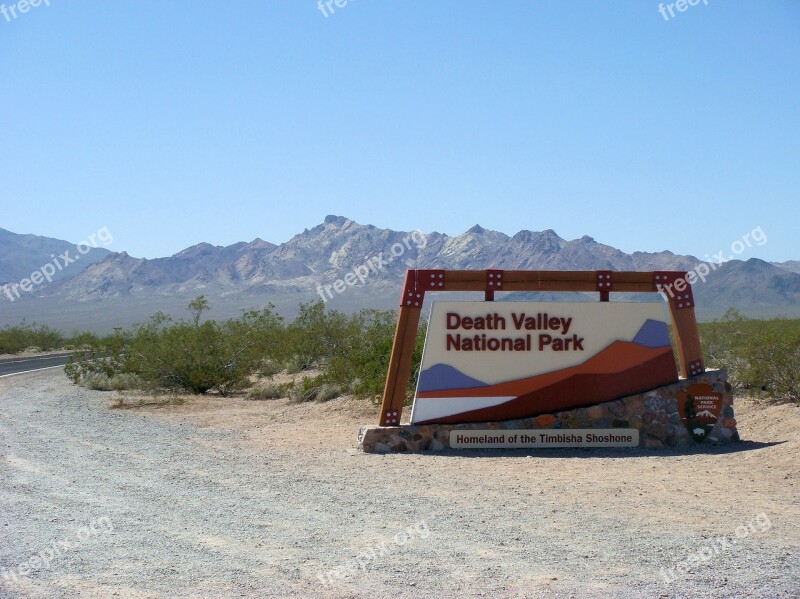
375;269;708;446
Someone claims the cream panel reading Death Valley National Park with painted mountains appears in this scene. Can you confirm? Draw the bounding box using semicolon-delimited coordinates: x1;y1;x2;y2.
411;302;678;424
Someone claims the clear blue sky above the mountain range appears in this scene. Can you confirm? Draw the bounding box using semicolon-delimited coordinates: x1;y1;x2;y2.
0;0;800;260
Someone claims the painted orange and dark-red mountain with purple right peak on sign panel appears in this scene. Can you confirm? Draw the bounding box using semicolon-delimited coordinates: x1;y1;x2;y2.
414;320;678;424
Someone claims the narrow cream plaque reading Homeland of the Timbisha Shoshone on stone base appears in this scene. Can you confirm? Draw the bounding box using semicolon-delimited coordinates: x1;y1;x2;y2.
450;428;639;449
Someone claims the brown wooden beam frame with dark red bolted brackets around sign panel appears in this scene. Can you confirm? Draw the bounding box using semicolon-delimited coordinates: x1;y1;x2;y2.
378;269;705;426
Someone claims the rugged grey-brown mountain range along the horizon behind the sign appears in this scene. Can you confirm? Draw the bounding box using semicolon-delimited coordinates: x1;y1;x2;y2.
0;216;800;331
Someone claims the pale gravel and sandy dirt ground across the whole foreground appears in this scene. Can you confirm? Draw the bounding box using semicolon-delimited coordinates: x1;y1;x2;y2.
0;370;800;598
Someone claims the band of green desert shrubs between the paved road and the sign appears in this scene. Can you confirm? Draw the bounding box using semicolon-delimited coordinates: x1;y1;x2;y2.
65;296;425;402
